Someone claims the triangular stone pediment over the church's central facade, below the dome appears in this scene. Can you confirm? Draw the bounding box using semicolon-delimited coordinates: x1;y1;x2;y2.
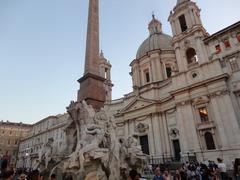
120;97;155;113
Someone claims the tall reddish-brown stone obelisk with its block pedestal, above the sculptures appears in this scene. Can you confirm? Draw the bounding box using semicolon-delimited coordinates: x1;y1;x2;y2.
78;0;106;109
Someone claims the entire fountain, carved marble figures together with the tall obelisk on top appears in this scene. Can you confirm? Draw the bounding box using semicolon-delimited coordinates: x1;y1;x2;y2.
36;0;146;180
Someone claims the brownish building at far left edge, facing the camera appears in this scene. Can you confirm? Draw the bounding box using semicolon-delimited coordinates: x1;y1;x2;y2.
0;121;32;164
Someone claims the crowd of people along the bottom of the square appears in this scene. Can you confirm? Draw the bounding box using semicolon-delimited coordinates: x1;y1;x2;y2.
0;158;240;180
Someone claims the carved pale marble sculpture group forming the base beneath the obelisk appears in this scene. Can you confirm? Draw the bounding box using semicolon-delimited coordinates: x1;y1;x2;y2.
45;101;146;180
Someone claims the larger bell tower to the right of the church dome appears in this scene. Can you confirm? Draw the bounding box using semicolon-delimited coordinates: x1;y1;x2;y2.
168;0;208;72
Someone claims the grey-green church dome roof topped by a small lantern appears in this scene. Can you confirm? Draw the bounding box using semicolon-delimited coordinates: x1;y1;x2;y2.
136;15;173;59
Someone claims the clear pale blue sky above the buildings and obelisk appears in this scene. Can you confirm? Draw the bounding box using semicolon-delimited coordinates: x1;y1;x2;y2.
0;0;240;123
